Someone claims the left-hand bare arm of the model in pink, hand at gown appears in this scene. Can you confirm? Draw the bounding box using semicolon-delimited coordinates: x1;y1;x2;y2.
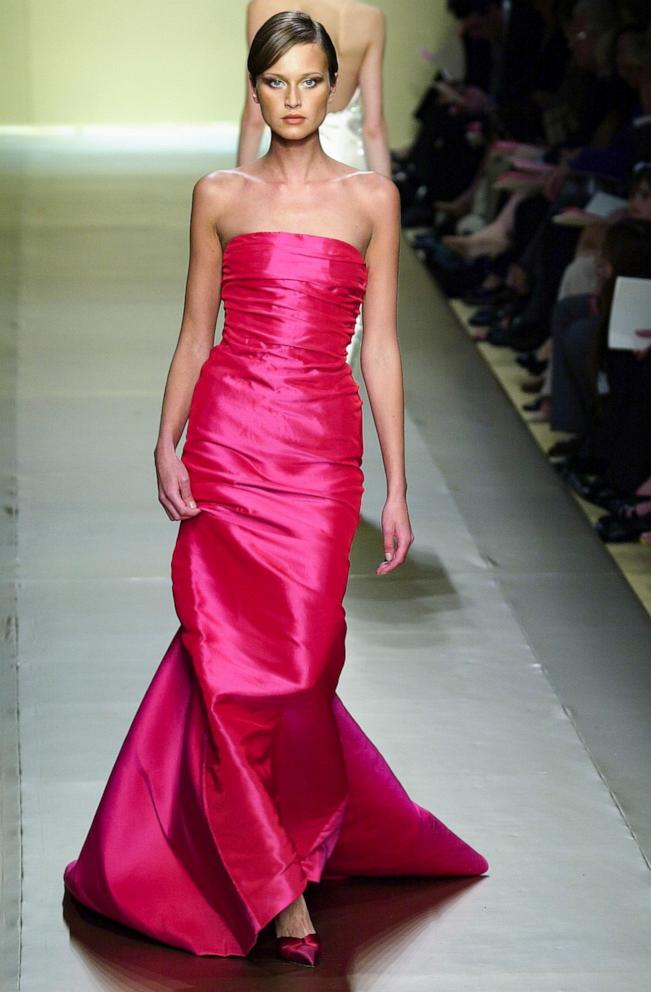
154;176;222;520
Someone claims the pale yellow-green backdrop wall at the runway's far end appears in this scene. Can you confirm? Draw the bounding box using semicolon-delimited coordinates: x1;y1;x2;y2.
0;0;449;144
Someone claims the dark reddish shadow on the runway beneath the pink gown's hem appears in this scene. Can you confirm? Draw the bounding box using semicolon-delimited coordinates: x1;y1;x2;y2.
63;878;481;992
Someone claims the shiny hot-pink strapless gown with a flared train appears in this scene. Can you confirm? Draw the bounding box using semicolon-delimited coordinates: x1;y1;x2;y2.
65;231;488;955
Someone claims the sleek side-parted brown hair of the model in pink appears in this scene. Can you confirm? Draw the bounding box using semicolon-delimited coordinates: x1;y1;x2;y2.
246;10;339;85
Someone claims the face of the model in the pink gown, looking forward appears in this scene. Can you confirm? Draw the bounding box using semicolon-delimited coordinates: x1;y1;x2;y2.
253;45;334;140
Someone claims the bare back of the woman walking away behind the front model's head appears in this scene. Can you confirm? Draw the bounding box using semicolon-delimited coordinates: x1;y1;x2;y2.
249;0;383;111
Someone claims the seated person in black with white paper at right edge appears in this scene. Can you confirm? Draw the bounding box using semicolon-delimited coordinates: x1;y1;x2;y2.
550;218;651;540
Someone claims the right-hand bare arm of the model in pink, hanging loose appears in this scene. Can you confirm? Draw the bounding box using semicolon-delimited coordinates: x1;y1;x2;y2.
360;176;414;575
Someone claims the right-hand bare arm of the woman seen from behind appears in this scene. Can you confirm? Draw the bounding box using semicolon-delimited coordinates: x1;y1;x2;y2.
359;10;391;176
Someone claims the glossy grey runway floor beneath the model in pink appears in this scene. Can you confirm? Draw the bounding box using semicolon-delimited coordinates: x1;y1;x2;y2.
0;132;651;992
